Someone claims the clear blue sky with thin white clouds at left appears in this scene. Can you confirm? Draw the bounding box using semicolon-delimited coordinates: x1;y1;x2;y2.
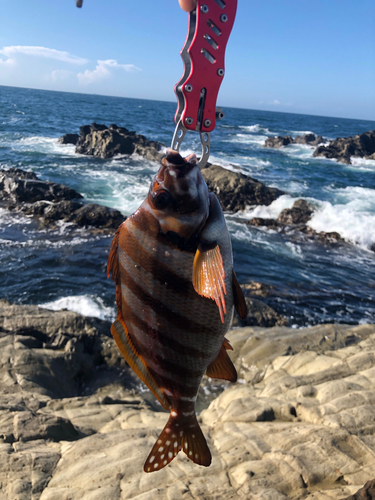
0;0;375;120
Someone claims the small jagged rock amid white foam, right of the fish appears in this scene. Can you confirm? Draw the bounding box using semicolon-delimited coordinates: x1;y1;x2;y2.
248;199;345;246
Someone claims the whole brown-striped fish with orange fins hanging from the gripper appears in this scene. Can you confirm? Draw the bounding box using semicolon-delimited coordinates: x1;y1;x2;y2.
107;149;246;472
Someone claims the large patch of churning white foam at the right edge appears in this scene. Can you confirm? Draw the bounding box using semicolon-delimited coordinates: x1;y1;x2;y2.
308;186;375;249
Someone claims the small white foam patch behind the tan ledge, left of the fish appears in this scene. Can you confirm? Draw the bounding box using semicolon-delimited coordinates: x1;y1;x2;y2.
38;295;115;321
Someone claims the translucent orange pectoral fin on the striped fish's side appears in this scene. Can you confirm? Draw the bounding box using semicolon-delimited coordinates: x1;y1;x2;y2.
193;245;227;323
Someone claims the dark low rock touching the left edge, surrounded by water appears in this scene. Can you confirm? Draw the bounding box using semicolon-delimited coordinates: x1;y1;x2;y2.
0;169;83;203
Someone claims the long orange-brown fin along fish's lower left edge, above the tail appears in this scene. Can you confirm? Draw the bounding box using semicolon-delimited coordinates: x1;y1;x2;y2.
111;318;171;410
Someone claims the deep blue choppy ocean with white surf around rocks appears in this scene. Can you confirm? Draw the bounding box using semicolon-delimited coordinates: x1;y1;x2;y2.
0;86;375;328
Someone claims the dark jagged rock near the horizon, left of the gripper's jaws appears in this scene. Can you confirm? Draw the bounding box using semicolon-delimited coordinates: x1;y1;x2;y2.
70;123;164;161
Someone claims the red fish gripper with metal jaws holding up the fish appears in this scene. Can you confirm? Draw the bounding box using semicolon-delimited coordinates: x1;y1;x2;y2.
172;0;237;166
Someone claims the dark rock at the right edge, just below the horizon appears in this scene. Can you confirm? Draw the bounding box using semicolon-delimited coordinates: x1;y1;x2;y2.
314;130;375;165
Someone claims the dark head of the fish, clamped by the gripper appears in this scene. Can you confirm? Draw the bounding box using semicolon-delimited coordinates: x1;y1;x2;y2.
147;149;210;242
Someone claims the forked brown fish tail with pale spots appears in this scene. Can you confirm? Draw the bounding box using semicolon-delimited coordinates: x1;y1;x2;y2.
143;410;211;472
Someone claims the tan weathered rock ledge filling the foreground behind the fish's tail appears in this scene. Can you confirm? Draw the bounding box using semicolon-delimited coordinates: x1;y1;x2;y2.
0;301;375;500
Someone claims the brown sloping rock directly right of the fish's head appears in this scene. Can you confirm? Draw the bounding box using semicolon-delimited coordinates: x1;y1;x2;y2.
202;165;285;212
